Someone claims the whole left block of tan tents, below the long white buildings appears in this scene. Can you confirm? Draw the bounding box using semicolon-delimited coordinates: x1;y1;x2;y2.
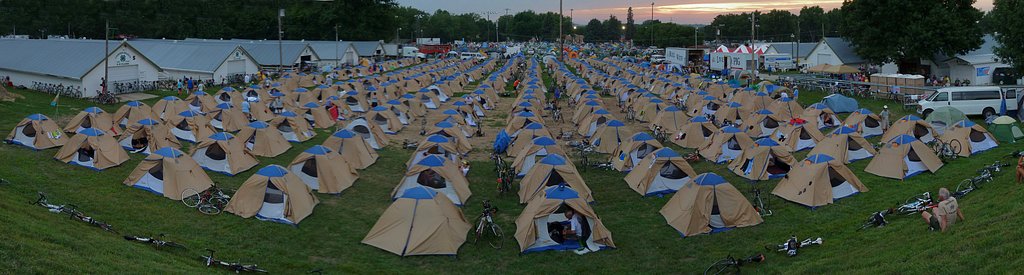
5;55;497;225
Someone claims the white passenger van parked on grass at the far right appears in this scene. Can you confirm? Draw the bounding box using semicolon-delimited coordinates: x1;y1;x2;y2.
918;86;1021;118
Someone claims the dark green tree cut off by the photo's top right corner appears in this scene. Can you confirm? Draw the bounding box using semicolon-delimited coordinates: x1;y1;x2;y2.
986;0;1024;72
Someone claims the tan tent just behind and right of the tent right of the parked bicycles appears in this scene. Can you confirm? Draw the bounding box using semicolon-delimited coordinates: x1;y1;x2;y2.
289;145;359;194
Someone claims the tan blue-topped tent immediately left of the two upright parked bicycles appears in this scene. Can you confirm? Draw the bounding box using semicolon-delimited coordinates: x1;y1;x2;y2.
124;147;213;200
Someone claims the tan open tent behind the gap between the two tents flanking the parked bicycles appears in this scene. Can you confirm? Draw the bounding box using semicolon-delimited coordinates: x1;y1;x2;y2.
188;132;259;176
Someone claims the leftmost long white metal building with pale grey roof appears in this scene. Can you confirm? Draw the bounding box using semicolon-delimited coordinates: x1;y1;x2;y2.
0;39;161;97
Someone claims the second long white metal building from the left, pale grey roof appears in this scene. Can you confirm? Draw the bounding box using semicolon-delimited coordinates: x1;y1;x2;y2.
128;40;259;82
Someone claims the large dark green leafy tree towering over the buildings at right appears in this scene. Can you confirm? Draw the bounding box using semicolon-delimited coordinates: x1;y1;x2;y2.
842;0;982;66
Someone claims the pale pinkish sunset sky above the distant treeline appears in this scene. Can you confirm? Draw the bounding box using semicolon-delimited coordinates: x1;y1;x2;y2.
397;0;992;25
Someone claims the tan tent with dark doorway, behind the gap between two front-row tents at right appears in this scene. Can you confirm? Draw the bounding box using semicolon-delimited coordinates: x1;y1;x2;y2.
729;138;797;181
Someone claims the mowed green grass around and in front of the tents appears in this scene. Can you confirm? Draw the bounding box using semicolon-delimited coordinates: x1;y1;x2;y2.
0;84;1024;274
